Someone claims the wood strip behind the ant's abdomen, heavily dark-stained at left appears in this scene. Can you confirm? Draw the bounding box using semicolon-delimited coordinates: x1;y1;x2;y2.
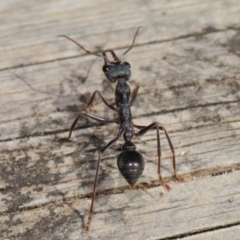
0;117;240;212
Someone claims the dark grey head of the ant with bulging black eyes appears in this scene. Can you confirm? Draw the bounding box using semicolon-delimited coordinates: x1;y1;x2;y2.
102;56;131;83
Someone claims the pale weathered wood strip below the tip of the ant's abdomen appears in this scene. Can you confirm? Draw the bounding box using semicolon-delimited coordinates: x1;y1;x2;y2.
0;171;240;240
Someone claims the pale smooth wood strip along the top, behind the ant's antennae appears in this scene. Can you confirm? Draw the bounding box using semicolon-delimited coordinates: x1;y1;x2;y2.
0;0;240;69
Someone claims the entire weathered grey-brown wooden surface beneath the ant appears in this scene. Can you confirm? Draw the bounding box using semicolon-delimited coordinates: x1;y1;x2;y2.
0;0;240;240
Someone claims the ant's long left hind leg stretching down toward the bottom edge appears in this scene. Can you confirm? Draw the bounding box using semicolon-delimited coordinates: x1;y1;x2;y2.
85;129;124;232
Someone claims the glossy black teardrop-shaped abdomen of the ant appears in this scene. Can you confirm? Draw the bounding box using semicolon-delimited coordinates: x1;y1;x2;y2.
117;150;145;186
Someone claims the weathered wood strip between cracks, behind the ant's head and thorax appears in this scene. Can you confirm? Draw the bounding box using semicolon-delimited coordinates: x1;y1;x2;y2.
0;30;240;140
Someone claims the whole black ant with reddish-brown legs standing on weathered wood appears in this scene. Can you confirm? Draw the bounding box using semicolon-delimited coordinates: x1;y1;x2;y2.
55;27;179;232
